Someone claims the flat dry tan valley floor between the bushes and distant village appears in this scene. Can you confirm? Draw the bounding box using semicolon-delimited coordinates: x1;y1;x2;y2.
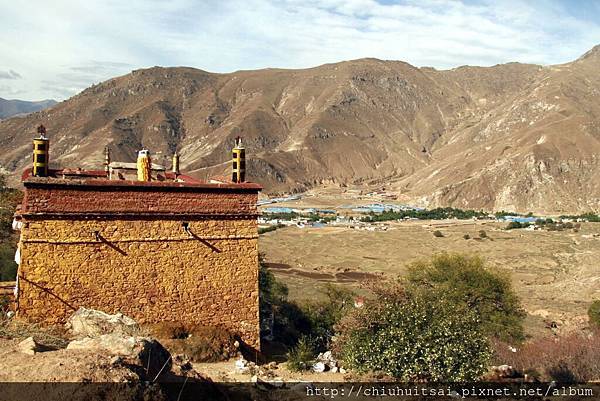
259;220;600;335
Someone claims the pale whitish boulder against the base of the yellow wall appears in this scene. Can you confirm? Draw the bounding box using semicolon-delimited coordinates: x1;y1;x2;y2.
67;308;140;338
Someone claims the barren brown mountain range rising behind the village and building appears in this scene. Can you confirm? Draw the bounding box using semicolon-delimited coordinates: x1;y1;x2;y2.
0;46;600;212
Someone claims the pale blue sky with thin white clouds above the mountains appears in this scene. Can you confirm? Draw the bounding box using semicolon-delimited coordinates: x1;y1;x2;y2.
0;0;600;100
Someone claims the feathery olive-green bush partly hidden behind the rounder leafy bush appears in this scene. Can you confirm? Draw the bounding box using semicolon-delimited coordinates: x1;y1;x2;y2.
407;253;525;342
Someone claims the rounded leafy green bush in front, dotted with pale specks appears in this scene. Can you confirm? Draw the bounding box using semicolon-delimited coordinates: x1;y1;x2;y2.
335;286;491;382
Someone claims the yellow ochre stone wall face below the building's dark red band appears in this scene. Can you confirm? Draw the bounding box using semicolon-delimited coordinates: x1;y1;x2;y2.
18;217;260;349
